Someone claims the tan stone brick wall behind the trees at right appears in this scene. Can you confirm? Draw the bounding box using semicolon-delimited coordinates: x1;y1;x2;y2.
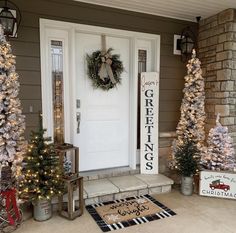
198;9;236;146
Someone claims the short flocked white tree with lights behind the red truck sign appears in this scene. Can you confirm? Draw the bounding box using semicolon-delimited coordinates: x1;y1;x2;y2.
201;114;236;171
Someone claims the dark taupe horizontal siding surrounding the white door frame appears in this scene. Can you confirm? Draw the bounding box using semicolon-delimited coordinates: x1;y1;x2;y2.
11;0;196;135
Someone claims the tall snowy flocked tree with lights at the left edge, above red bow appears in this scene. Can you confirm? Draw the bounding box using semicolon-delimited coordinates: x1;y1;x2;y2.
0;25;25;175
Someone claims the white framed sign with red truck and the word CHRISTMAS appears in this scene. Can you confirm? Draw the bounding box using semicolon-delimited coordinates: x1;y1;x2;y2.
199;171;236;199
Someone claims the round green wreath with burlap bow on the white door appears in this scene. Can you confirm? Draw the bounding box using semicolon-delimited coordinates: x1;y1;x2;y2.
87;48;124;90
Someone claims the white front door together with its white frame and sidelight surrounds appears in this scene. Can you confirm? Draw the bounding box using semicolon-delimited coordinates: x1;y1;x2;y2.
40;19;160;171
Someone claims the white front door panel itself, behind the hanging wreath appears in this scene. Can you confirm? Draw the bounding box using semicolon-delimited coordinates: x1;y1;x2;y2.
73;33;130;171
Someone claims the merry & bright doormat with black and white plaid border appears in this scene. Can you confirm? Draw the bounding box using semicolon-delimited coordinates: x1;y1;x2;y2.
86;194;176;232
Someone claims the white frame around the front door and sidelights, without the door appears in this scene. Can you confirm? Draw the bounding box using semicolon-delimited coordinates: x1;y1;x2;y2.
40;18;160;169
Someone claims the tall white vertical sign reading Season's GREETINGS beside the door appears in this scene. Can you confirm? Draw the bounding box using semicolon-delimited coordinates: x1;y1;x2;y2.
140;72;159;174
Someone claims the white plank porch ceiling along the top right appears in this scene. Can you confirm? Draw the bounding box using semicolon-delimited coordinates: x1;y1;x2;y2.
75;0;236;21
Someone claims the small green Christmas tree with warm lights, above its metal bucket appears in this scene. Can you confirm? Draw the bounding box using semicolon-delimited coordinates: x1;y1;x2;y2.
19;116;63;201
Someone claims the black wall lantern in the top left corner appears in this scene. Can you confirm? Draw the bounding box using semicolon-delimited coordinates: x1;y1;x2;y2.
0;0;21;37
